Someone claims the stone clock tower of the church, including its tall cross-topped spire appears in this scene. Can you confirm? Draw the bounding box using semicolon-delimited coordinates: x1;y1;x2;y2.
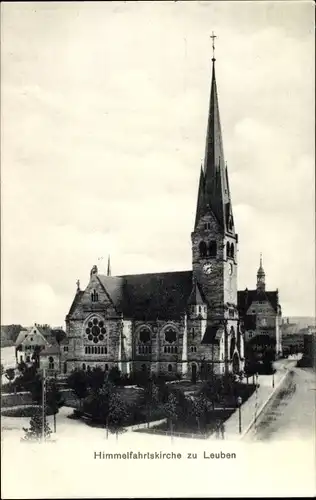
191;35;238;332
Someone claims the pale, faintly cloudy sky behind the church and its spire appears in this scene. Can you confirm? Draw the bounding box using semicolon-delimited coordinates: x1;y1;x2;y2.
1;1;315;326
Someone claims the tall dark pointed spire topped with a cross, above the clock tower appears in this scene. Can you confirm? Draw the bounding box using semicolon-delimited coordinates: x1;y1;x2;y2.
200;33;232;229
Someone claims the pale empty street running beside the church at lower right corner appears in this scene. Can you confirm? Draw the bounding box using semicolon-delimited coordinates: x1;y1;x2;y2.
245;367;316;441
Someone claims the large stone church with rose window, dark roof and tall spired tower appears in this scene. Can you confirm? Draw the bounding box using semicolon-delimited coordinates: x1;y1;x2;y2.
66;45;244;377
